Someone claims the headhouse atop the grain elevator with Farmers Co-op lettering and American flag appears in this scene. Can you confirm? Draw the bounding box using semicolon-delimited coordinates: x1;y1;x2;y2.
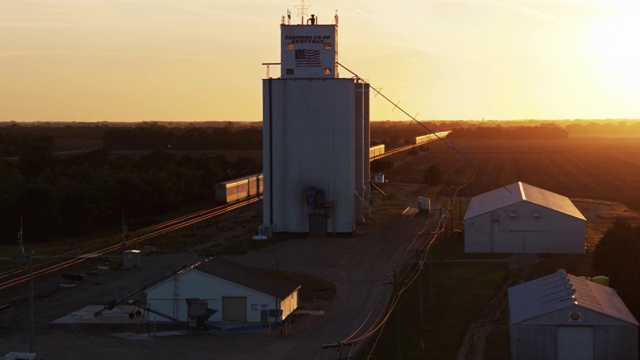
280;15;338;79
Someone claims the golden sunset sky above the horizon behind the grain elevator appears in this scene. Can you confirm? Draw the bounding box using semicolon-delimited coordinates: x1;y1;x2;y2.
0;0;640;121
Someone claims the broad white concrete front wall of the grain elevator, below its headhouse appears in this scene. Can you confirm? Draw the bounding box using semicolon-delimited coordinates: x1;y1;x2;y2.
263;79;361;233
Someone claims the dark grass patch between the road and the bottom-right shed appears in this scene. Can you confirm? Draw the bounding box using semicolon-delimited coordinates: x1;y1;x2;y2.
357;262;508;359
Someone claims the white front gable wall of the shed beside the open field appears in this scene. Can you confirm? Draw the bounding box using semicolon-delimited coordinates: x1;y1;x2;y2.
464;201;586;254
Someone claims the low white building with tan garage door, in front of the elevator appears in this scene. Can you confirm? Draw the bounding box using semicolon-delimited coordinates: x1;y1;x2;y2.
145;258;300;322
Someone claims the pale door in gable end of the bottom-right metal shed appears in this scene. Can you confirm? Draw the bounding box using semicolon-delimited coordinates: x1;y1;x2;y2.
556;326;593;360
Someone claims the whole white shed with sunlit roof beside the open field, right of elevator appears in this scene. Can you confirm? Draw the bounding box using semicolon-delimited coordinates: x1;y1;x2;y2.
464;182;586;254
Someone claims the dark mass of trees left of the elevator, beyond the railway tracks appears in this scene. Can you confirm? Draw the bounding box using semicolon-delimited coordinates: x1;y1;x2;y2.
0;126;261;241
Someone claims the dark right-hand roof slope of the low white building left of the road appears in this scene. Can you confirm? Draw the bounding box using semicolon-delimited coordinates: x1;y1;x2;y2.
191;257;300;299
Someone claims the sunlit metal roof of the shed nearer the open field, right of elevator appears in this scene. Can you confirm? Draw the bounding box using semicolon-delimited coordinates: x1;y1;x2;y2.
464;181;586;221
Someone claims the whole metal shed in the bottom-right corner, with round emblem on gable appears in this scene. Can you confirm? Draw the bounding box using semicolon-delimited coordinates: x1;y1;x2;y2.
509;269;638;360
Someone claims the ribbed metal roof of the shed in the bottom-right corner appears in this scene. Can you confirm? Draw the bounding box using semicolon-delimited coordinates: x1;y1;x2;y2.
509;269;638;325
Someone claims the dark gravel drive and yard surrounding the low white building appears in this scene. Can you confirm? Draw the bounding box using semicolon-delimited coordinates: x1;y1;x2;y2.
0;207;426;360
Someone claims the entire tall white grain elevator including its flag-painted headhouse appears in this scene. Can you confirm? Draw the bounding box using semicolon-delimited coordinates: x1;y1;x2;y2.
261;9;369;236
